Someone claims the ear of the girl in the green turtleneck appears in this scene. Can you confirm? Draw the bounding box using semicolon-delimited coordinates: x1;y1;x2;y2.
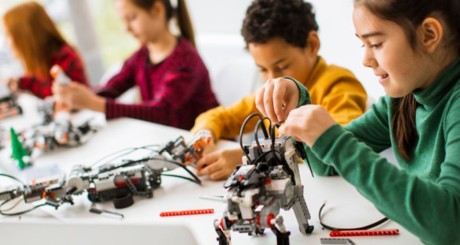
419;17;444;53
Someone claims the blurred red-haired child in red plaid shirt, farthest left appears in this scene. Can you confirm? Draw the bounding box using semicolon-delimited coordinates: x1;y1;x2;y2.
3;2;88;98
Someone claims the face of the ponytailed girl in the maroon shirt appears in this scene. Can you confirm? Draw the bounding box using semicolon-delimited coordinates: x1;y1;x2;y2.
116;0;165;44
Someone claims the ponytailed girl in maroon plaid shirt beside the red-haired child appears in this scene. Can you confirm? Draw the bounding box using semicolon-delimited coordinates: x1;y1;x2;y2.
54;0;218;129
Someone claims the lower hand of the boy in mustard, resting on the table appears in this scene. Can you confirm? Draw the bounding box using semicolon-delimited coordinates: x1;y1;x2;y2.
197;148;243;180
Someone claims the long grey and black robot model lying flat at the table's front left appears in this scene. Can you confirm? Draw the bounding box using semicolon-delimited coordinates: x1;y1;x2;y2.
0;163;161;211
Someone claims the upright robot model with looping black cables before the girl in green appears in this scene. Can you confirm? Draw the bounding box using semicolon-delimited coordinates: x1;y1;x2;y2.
214;114;314;245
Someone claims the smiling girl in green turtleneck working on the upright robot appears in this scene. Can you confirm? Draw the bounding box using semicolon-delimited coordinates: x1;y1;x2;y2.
257;0;460;244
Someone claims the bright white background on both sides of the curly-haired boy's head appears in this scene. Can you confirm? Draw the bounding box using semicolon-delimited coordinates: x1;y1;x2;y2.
188;0;384;99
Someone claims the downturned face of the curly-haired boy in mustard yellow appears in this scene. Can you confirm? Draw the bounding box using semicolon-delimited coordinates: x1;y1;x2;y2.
248;38;317;84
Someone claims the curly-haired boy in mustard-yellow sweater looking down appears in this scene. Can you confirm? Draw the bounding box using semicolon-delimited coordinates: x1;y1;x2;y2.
192;0;367;180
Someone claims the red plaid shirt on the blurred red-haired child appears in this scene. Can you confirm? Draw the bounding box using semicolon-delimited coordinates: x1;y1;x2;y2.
19;44;88;99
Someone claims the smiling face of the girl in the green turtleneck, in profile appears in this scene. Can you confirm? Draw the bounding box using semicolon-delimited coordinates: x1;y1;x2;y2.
353;5;432;97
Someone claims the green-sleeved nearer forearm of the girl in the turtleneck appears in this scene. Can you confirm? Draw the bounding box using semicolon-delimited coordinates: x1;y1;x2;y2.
312;125;460;244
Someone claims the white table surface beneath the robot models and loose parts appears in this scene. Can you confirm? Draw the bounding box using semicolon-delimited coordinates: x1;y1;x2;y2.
0;94;421;245
